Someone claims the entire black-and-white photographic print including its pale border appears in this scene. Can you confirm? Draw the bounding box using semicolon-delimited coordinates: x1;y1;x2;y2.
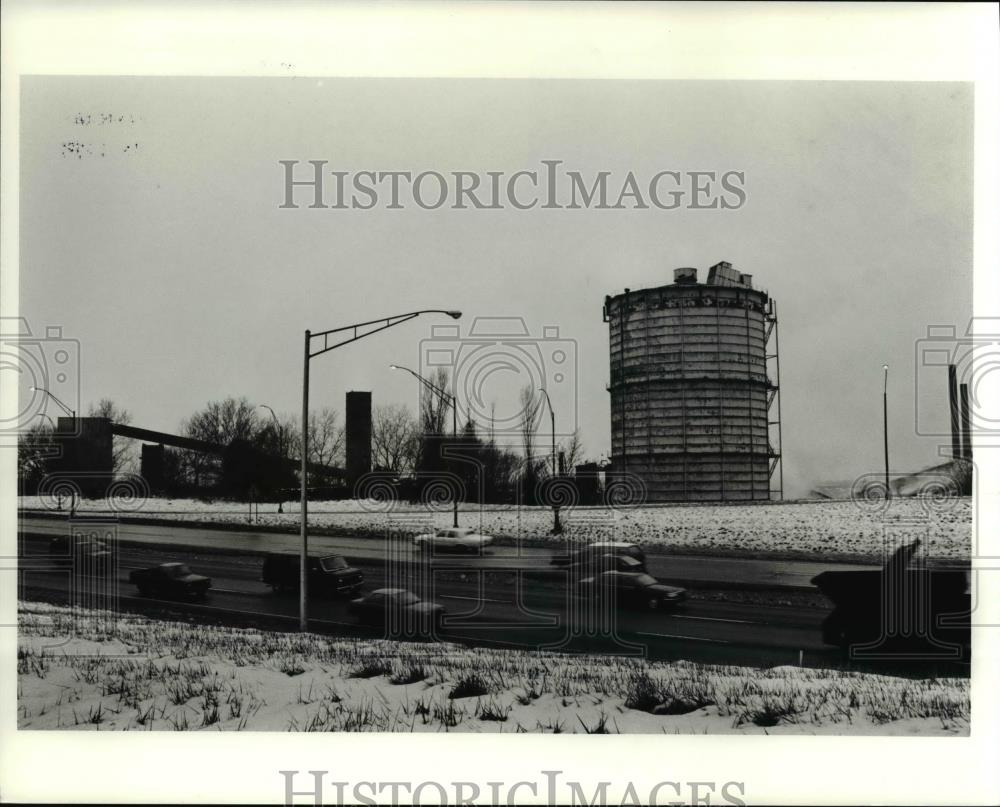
0;3;1000;805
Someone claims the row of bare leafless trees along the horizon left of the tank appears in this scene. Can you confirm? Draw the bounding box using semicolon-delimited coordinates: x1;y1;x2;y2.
18;370;582;501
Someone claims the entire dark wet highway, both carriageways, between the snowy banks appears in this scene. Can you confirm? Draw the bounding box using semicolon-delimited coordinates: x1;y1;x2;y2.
18;519;962;674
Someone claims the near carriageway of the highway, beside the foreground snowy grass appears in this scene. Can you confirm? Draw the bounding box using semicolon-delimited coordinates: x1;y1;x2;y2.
21;534;836;665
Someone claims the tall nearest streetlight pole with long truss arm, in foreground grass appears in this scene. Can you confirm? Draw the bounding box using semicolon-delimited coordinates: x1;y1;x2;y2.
299;308;462;631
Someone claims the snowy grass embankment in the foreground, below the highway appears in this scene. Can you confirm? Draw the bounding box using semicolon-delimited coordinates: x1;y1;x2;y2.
18;603;969;735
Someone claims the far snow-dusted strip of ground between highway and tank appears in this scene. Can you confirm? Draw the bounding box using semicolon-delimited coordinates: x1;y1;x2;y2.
20;496;972;562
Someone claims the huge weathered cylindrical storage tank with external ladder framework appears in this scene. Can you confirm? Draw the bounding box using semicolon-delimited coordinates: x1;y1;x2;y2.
604;262;783;502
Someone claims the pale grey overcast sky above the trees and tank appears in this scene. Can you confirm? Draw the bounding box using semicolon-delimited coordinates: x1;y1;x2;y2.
20;77;972;495
